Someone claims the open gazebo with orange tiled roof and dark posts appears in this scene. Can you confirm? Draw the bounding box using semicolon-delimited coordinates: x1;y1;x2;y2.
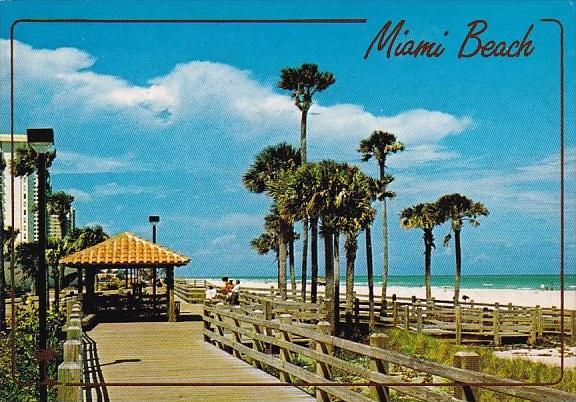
60;232;190;321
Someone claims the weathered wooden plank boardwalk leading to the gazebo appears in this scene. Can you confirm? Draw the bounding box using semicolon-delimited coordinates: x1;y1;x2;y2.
84;301;315;402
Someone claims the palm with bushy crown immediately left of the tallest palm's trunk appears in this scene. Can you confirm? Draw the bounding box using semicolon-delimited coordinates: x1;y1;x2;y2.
242;143;300;299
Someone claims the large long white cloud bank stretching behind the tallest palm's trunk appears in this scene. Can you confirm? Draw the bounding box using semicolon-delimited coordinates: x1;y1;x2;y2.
0;40;472;164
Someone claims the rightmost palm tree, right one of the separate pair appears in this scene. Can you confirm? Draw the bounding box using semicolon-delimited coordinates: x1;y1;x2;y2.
436;193;489;304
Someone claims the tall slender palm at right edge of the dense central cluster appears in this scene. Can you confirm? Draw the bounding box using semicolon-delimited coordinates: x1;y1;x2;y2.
358;130;404;316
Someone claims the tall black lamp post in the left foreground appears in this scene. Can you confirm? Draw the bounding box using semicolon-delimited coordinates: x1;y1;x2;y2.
26;128;54;402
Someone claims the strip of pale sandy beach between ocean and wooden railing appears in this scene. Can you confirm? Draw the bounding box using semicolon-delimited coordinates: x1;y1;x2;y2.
234;280;576;310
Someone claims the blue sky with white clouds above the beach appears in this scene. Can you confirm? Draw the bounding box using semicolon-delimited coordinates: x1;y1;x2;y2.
0;1;576;276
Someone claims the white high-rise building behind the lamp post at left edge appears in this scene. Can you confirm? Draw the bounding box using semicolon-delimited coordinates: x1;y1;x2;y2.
0;134;38;243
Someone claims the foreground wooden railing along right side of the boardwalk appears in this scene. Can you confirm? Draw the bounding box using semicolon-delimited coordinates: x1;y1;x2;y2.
203;304;574;402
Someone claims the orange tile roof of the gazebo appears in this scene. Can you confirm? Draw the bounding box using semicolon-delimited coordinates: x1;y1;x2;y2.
60;232;190;267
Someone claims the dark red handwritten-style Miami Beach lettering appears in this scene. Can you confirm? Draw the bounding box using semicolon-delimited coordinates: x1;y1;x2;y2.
364;20;534;59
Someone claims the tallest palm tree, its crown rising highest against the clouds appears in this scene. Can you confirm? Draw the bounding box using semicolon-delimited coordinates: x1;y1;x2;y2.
278;64;336;301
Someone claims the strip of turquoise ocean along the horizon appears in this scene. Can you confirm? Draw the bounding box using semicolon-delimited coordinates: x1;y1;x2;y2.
180;274;576;291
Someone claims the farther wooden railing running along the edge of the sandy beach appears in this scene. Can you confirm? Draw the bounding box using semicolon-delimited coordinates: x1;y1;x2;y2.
231;287;576;345
